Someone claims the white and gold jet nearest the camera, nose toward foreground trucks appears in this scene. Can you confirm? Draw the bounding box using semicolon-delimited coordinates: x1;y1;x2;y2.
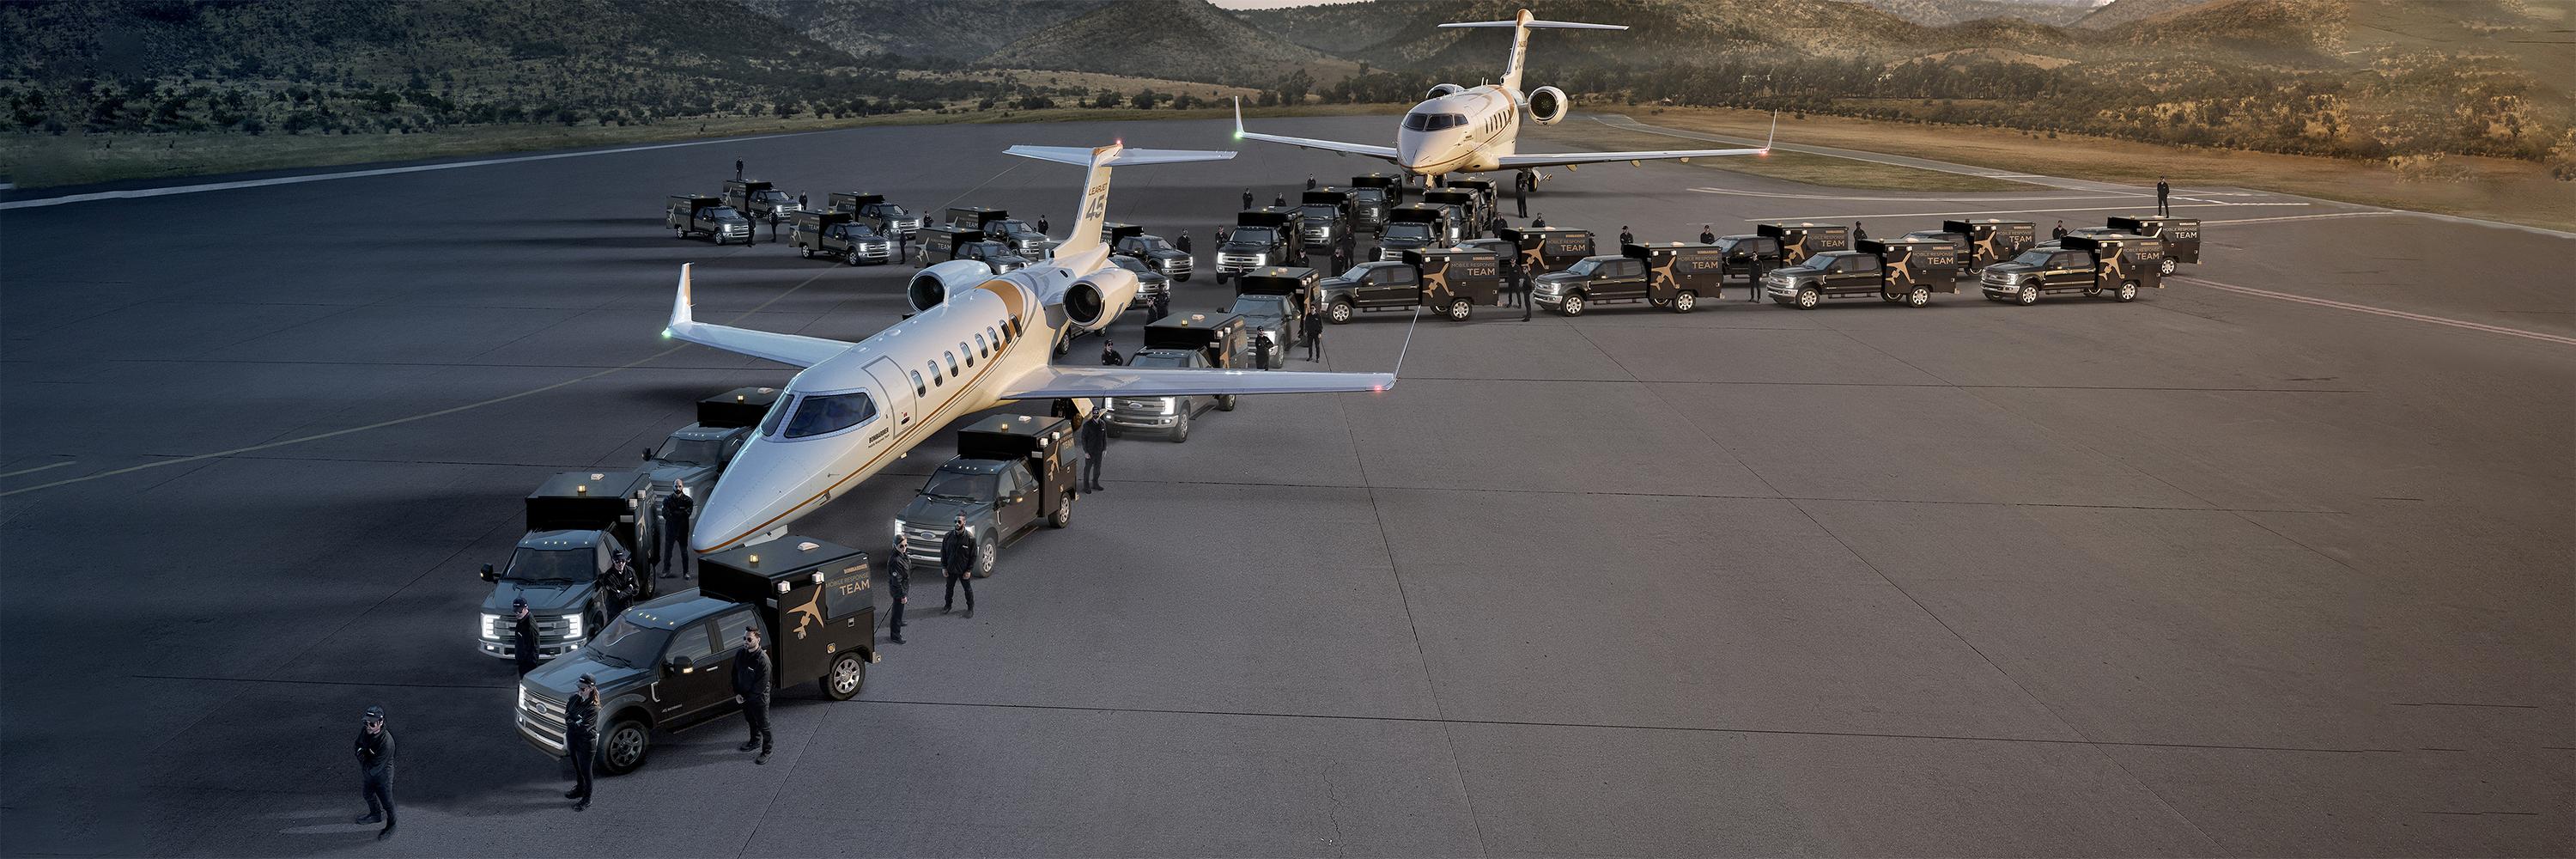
662;144;1396;552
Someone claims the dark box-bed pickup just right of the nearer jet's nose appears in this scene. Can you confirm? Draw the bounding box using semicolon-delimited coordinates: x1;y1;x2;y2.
894;415;1082;578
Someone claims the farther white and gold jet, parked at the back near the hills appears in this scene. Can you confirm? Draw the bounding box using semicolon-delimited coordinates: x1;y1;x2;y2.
1234;10;1777;175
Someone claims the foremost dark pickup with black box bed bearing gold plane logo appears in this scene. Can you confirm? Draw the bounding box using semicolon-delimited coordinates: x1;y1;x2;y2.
513;534;876;777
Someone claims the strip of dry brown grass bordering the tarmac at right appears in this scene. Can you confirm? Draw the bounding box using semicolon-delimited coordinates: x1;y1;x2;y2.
1620;108;2576;229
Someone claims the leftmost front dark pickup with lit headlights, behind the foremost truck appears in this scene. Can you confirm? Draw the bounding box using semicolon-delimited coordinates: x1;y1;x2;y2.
477;472;654;661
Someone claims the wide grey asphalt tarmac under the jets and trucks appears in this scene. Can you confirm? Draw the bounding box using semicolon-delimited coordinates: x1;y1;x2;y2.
0;116;2576;856
